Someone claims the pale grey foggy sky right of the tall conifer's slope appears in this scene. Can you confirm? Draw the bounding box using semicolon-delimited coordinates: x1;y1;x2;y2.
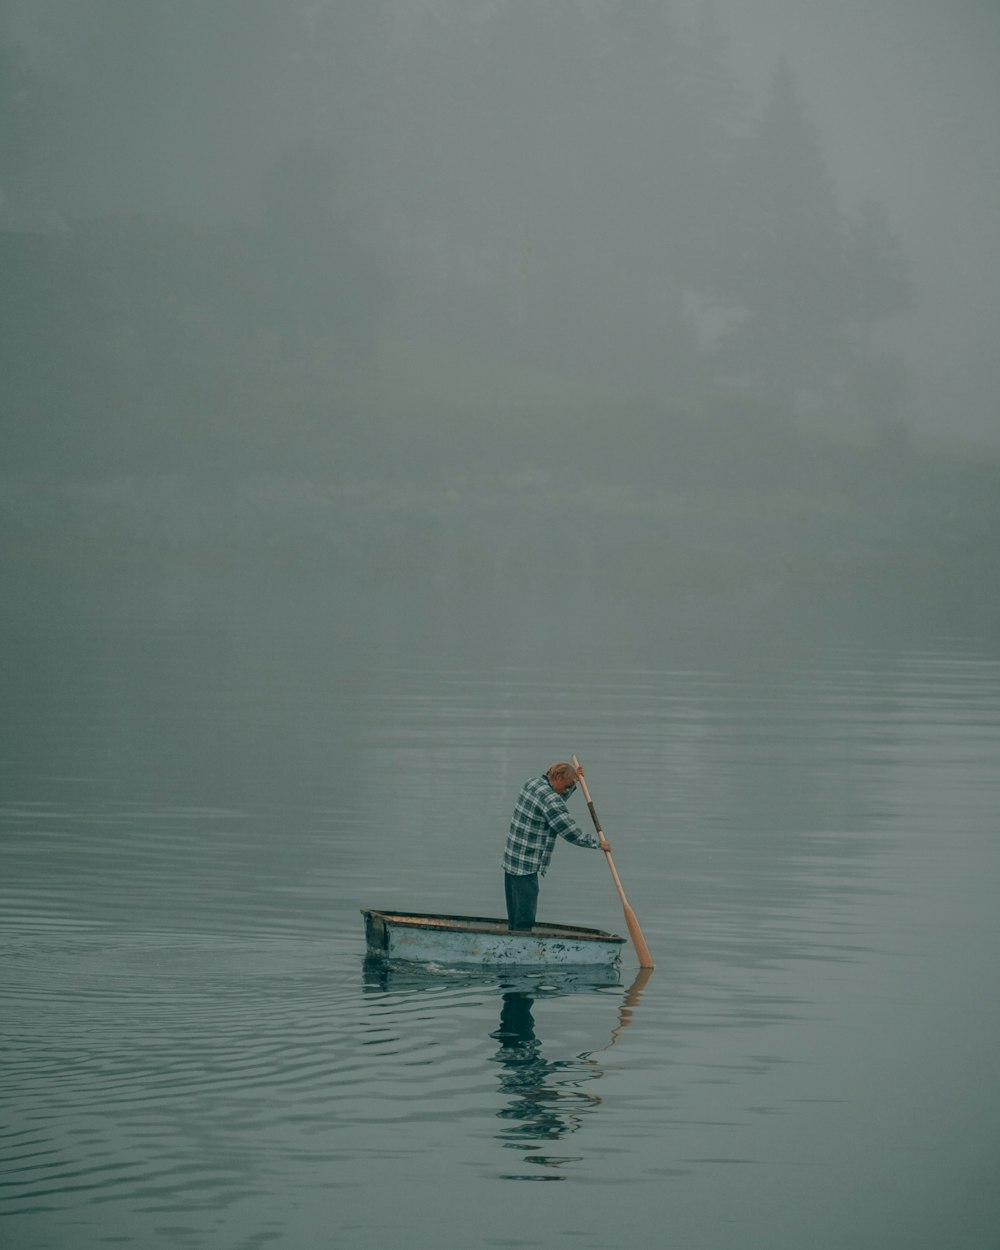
718;0;1000;443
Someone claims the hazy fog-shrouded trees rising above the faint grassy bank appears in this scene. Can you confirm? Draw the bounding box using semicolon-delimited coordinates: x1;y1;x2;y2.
0;0;910;458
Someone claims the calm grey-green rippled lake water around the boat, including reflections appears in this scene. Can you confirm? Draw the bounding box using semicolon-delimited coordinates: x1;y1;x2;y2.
0;604;1000;1250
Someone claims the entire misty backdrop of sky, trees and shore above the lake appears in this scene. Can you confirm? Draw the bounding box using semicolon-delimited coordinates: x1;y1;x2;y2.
0;0;1000;634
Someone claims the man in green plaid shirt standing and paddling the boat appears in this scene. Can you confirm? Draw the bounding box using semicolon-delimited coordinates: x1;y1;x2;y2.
504;764;601;929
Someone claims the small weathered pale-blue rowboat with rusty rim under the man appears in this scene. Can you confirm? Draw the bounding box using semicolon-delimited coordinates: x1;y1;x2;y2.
361;910;625;969
